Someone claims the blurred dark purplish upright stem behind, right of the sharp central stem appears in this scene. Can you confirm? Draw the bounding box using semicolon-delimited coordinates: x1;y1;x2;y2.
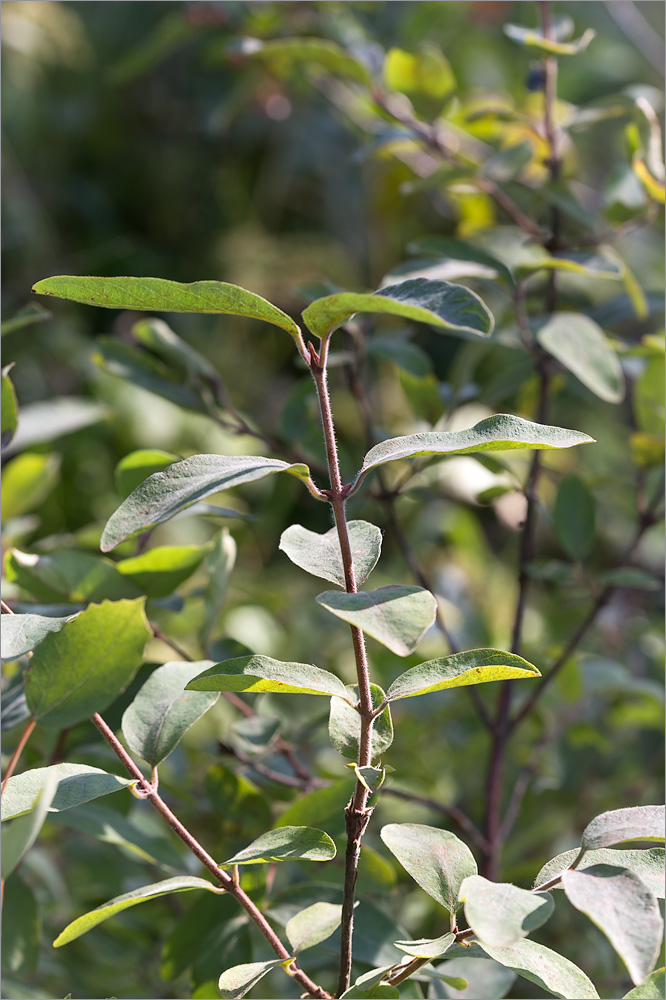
484;0;560;881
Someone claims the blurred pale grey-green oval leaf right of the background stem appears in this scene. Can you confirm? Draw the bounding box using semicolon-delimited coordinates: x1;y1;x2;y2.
536;312;624;403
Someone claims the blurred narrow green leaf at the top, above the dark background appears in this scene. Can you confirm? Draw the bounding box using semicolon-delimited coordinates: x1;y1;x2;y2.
227;38;370;84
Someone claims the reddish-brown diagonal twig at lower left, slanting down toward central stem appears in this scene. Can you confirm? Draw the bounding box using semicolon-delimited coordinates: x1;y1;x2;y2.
92;713;331;1000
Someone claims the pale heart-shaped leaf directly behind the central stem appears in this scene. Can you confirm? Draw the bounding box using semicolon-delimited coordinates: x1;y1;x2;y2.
280;521;382;588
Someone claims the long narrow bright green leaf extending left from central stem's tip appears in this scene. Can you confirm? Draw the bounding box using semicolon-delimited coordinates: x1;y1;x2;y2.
32;275;300;338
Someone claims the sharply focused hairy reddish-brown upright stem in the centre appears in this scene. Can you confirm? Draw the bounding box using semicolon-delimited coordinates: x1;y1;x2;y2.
310;339;374;996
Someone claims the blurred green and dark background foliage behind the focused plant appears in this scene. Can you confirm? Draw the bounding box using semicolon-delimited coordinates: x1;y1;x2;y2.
2;0;664;998
